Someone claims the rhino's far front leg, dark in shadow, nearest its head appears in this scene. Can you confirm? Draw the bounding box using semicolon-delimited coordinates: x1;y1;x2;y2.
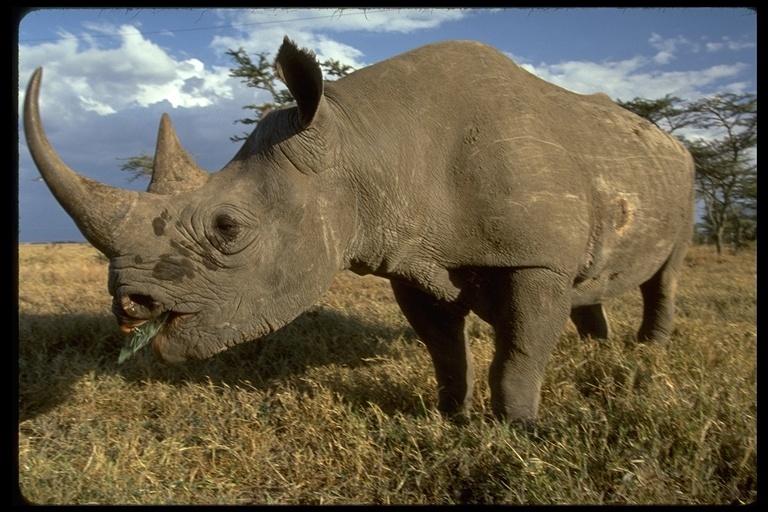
391;281;474;420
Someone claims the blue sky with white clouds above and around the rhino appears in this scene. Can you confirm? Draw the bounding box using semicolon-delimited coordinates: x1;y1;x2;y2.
18;8;757;242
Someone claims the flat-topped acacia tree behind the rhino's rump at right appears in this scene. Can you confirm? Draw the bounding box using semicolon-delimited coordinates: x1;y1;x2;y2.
618;94;757;253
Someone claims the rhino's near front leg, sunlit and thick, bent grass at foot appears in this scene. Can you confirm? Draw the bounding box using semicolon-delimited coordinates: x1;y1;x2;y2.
488;268;572;427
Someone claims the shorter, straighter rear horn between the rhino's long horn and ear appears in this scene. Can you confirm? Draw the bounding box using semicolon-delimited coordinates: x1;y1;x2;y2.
147;114;210;195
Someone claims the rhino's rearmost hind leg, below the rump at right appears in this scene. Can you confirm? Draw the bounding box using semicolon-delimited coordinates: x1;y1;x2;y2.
637;245;688;344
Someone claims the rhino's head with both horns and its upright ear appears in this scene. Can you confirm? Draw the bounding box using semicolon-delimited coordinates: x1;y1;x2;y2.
24;38;353;361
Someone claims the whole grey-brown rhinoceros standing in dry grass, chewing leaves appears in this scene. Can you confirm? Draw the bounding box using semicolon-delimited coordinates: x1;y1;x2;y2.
24;38;693;423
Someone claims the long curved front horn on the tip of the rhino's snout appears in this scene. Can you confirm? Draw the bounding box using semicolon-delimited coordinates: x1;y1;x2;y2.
24;68;140;257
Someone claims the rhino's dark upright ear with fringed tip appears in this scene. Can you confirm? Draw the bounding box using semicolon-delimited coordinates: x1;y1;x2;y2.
275;36;323;128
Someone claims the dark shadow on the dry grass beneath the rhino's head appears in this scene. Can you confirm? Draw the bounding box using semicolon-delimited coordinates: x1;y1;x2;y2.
19;308;416;421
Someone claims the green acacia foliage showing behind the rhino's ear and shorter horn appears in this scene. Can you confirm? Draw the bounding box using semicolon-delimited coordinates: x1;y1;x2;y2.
118;48;354;178
